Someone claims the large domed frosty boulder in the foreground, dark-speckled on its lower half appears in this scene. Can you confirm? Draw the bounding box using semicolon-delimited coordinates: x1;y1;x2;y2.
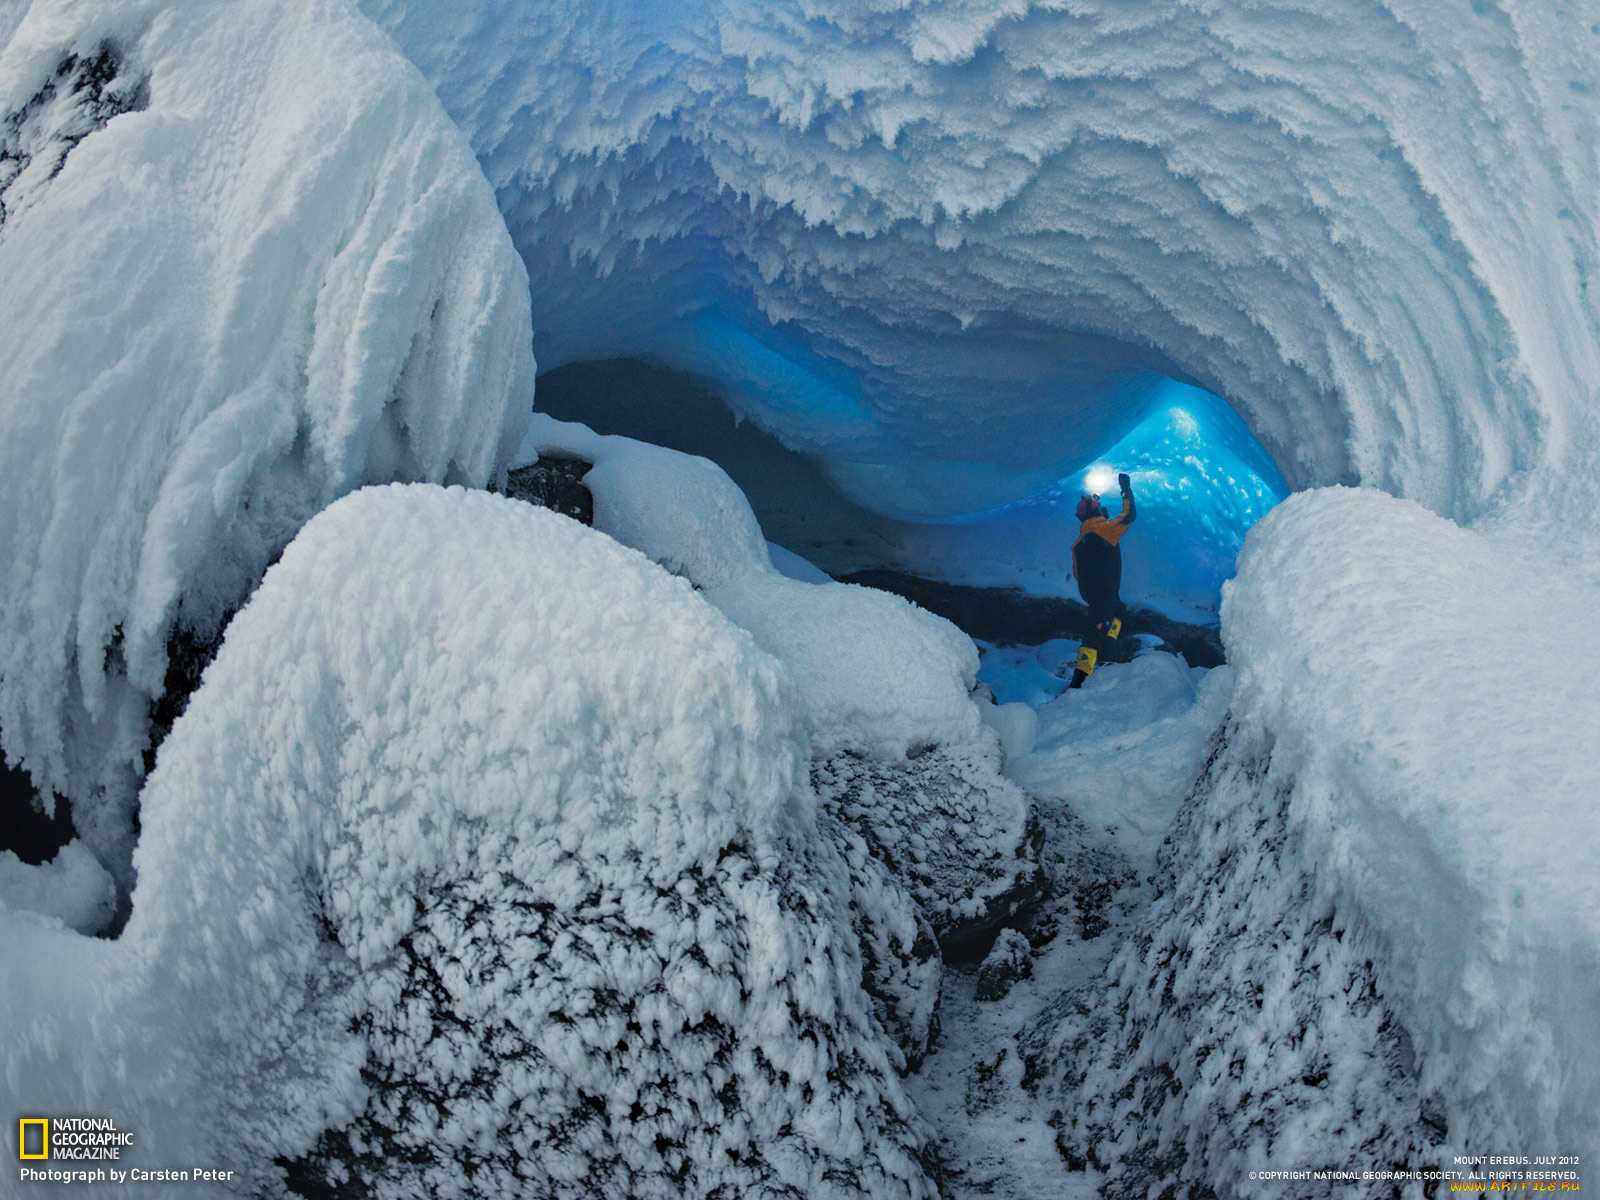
0;485;934;1197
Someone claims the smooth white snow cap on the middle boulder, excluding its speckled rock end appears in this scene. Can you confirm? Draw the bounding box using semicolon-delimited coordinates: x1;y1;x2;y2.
517;414;987;757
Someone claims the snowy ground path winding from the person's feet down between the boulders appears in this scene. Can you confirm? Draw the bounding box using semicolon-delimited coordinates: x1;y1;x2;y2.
909;642;1232;1200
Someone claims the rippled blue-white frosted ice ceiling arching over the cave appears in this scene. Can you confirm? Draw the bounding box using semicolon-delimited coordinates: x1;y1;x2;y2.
363;0;1600;520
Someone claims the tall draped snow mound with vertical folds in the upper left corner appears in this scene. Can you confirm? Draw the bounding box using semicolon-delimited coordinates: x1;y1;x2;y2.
0;0;533;886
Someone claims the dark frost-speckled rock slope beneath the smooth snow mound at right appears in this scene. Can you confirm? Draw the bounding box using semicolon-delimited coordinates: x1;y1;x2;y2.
1024;729;1446;1200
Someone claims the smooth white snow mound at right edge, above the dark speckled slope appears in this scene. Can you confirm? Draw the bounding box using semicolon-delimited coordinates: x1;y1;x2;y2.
1222;488;1600;1154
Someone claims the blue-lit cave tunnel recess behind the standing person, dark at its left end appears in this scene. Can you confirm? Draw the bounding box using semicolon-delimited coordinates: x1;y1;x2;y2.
536;358;1288;624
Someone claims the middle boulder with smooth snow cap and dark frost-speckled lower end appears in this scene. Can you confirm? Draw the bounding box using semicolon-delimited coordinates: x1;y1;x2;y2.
505;416;1042;957
